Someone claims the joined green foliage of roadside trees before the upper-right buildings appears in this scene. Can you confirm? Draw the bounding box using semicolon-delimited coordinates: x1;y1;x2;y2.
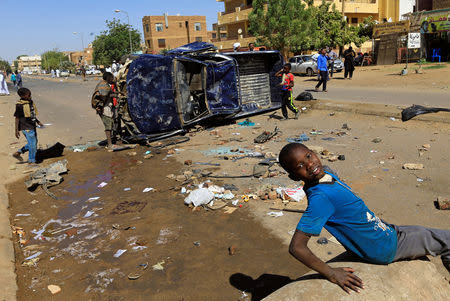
249;0;374;57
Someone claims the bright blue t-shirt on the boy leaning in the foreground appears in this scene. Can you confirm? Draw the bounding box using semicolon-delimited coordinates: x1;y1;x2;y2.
297;172;397;264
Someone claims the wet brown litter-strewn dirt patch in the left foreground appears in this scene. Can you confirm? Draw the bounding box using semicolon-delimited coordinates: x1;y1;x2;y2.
8;148;306;300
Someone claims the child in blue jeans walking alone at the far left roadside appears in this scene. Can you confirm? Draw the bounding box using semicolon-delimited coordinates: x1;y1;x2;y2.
13;88;43;164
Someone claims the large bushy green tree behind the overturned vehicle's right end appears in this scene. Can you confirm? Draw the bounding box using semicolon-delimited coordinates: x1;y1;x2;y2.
248;0;315;58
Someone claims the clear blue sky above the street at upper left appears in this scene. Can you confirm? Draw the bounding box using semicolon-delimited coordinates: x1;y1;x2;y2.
0;0;224;62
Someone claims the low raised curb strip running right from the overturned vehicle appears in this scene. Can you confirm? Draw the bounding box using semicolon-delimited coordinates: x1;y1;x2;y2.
310;99;450;123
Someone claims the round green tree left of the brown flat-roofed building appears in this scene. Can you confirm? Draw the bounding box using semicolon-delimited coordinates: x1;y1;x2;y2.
92;19;141;66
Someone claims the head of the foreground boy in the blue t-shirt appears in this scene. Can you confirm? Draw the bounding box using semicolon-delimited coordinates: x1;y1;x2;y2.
279;143;325;183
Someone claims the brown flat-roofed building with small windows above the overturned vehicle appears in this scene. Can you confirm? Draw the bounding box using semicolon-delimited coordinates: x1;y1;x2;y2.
142;14;208;54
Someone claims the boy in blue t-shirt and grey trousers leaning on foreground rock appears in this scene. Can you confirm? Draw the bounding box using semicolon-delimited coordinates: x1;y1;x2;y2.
279;143;450;293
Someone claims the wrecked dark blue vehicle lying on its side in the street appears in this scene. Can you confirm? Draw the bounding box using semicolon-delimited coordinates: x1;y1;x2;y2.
127;42;284;135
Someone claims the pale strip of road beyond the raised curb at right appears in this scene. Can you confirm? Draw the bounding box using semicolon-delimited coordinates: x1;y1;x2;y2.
294;78;450;108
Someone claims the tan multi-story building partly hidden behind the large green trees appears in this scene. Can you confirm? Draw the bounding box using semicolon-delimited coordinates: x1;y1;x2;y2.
214;0;400;51
